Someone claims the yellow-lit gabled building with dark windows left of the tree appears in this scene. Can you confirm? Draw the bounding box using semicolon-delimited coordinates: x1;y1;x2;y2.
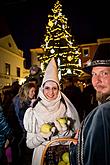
0;34;29;90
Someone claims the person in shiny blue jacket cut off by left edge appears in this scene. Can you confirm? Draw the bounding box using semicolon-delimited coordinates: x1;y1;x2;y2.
0;105;13;165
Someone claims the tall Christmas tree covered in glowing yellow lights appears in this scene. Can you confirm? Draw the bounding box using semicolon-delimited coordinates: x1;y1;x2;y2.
38;0;82;76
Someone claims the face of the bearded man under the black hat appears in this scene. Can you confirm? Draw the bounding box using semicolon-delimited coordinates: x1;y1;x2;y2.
92;66;110;102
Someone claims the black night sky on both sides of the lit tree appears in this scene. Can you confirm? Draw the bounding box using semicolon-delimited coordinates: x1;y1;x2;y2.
0;0;110;67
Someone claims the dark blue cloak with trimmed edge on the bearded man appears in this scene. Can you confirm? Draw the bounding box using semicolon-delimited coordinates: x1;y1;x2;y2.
77;96;110;165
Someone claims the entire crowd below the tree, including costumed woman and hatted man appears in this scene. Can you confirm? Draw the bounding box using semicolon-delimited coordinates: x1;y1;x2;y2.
0;43;110;165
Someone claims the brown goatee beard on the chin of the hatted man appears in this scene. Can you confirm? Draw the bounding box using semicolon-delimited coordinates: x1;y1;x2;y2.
96;92;110;103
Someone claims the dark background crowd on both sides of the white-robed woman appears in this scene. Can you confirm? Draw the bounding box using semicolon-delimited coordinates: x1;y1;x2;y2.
0;70;97;165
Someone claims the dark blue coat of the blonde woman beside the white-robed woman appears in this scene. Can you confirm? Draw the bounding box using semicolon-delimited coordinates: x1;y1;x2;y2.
11;95;33;165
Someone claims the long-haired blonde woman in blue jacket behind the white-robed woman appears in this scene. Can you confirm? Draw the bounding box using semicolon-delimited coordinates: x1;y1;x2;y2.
13;82;36;128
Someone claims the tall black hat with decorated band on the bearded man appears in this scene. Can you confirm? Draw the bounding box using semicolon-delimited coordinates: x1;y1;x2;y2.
83;43;110;73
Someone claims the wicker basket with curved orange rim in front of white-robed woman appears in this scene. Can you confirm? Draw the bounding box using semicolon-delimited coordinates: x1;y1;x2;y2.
41;138;77;165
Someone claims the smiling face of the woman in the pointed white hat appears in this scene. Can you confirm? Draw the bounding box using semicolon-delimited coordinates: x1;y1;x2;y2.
43;81;59;100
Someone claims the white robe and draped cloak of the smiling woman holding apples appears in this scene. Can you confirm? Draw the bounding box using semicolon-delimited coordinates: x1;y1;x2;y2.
24;89;80;165
